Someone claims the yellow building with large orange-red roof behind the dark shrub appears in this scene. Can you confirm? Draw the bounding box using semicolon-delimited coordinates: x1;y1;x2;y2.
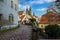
39;11;60;30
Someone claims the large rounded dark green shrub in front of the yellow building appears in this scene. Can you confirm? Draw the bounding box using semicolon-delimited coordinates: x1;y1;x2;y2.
45;24;60;38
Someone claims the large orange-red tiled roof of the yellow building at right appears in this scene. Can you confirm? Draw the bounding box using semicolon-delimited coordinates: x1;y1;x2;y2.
39;12;60;24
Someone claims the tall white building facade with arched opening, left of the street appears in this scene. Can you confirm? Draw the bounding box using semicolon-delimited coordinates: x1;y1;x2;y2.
0;0;18;28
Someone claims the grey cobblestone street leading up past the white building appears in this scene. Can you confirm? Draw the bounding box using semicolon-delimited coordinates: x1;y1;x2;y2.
0;25;32;40
